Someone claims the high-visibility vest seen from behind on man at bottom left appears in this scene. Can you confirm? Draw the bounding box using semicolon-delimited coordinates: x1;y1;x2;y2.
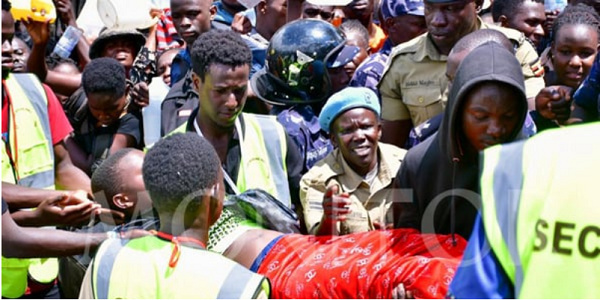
90;236;270;299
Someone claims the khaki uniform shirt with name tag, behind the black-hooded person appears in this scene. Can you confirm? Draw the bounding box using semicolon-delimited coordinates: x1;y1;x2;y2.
379;19;545;126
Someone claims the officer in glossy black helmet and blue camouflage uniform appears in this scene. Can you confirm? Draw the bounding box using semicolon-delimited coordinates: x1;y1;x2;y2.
251;19;359;173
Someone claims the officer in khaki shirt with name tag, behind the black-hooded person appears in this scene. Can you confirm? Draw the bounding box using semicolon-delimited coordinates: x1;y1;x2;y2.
379;0;544;147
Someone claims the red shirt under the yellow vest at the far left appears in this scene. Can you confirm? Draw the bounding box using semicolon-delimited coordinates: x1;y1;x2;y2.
2;80;73;145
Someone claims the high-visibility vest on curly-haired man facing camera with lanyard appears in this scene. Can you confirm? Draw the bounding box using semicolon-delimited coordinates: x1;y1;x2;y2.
169;113;291;207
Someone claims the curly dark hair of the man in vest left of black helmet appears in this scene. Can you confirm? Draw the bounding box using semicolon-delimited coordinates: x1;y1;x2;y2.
191;29;252;82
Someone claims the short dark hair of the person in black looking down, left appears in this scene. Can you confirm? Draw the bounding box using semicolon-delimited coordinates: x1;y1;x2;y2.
81;57;127;98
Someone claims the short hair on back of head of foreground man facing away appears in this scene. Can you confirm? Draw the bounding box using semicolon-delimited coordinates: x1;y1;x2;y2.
142;133;221;214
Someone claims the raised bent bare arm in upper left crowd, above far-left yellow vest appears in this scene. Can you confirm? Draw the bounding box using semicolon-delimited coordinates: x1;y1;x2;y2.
22;19;81;96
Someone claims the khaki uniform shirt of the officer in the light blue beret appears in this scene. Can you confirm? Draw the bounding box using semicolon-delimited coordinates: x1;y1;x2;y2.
300;143;406;234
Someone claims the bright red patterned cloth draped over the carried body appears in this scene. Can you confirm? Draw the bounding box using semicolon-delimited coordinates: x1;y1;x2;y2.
258;229;467;299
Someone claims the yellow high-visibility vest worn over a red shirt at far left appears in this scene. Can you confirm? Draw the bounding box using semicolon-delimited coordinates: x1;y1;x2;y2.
2;74;54;188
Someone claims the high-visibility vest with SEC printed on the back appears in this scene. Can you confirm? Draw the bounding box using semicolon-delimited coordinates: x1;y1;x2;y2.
481;124;600;298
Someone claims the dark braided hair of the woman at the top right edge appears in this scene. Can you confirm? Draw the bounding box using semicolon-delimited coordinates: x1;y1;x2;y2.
552;3;600;41
